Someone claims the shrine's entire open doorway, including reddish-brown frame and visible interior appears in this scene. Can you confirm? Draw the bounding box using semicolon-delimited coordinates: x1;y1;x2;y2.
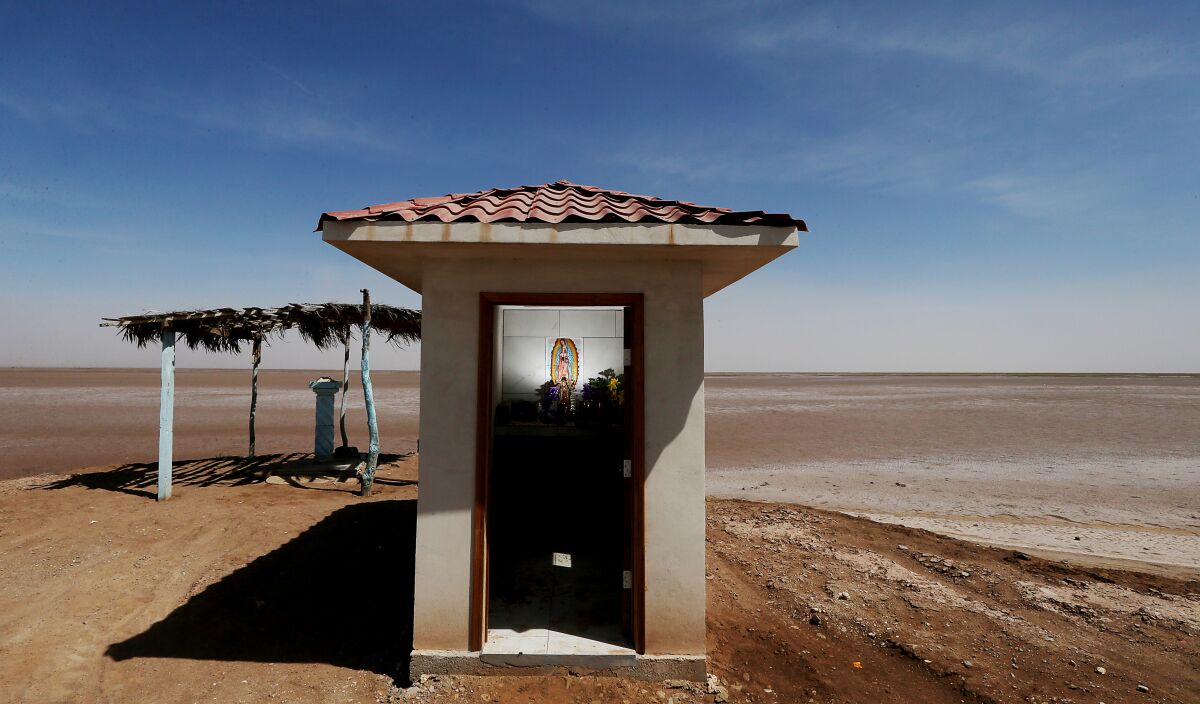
475;294;642;660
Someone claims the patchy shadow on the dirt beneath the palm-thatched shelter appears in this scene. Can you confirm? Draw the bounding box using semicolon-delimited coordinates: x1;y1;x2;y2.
40;452;414;499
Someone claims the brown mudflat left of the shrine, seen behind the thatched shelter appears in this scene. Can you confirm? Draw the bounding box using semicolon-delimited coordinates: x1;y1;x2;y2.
0;368;420;480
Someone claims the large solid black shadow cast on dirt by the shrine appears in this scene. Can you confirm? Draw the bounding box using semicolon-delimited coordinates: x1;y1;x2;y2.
106;499;416;685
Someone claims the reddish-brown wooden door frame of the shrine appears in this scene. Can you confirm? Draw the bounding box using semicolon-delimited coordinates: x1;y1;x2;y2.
467;291;646;654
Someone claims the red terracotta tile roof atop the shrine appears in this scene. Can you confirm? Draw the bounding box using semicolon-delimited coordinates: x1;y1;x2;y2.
317;181;808;231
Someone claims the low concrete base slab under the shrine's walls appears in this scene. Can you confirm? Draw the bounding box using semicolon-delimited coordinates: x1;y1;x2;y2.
409;650;708;682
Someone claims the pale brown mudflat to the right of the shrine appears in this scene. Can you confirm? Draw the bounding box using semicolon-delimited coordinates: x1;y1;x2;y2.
706;374;1200;568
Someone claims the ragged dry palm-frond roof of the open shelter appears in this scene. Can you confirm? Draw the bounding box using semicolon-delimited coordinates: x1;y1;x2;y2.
101;303;421;353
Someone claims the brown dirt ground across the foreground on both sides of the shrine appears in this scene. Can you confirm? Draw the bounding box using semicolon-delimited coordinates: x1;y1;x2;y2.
0;456;1200;704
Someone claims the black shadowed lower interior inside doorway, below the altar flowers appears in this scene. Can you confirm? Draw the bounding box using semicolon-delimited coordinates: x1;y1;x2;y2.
487;425;628;645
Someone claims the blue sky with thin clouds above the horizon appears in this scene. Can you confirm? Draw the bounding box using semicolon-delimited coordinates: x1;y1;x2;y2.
0;2;1200;372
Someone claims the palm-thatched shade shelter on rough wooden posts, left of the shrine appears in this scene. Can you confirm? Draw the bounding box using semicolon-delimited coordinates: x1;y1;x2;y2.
101;296;421;500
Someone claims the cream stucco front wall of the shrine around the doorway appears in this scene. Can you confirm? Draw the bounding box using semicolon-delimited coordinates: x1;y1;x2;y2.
413;259;706;655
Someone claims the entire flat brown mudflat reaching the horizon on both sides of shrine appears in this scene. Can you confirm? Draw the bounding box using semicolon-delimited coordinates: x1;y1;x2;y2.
0;368;1200;568
